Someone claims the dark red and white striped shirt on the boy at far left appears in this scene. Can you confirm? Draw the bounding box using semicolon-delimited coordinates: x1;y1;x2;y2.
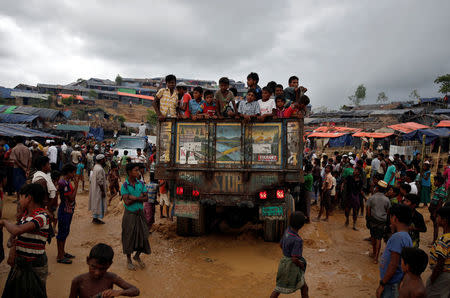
16;208;50;261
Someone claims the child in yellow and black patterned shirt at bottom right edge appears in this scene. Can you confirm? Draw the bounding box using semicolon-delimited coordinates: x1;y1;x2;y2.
426;206;450;297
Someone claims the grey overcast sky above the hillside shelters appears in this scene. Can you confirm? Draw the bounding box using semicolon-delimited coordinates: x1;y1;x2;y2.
0;0;450;108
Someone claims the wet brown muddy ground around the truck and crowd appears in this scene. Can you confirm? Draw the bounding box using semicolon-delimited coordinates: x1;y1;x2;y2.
0;192;431;298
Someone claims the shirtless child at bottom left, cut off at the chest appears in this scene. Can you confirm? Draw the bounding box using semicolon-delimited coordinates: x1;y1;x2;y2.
69;243;139;298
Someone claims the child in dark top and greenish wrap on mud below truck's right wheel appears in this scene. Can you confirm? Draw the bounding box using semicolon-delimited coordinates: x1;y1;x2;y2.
270;211;308;298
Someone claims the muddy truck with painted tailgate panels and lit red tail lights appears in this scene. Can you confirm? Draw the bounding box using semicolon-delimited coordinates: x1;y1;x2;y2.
155;118;303;241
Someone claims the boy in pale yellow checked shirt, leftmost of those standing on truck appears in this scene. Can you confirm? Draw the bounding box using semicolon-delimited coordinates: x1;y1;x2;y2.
153;74;178;119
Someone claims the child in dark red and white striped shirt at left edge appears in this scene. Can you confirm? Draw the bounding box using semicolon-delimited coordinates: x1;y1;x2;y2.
0;183;50;298
